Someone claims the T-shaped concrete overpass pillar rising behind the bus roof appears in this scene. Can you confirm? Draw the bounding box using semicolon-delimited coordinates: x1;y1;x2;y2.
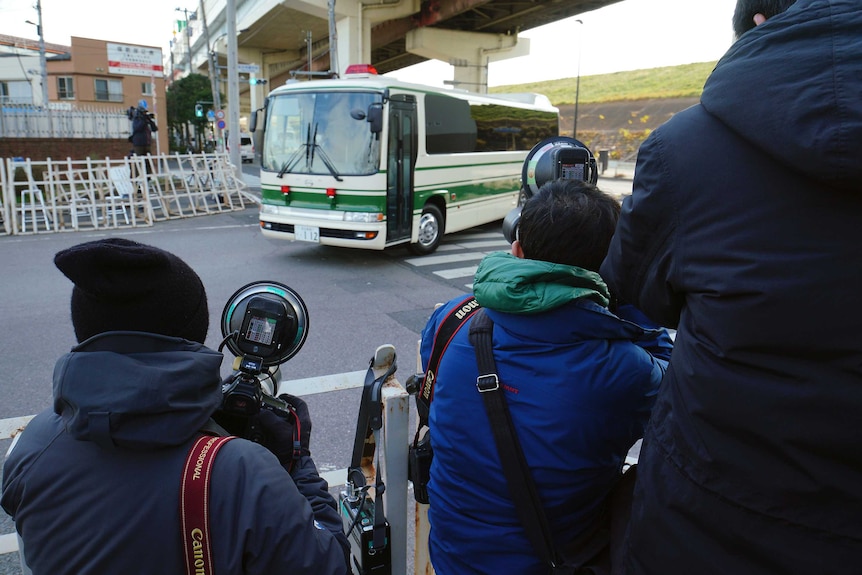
406;28;530;94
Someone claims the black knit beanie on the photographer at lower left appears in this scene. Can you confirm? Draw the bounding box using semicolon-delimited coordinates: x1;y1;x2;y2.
54;238;209;343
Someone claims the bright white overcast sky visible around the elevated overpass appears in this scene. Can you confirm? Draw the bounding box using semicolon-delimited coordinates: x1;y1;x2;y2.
0;0;736;86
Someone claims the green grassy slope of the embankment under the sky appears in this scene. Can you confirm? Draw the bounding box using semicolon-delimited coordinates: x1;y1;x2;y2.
489;62;715;106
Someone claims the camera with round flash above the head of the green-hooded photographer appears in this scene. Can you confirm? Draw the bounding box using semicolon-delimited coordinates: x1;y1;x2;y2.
503;136;599;243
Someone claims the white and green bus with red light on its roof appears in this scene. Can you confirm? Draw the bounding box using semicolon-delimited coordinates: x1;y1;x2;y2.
252;67;559;254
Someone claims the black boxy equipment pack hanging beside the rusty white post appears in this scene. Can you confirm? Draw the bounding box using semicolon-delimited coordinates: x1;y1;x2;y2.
338;485;392;575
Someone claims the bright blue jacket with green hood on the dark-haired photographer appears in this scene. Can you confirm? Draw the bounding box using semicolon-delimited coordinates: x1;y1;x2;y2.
421;252;671;575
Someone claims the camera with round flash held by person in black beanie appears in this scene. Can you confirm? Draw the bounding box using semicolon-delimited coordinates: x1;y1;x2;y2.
213;281;308;443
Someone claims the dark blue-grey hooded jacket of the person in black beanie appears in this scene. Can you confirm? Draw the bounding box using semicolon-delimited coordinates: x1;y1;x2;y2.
2;332;347;575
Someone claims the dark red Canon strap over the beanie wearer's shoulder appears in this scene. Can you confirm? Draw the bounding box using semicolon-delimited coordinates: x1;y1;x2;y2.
180;435;234;575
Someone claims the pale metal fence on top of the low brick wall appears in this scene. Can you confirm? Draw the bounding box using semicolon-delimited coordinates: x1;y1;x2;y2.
0;104;129;139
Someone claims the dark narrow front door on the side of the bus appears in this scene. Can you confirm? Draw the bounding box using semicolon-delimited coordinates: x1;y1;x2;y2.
386;94;418;243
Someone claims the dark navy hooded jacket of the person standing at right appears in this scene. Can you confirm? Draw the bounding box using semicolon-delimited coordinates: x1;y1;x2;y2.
601;0;862;575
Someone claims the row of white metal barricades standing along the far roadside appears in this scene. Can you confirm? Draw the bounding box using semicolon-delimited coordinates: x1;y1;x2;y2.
0;153;257;234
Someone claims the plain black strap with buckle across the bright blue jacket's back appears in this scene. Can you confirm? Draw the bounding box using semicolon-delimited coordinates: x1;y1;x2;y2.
470;310;572;573
